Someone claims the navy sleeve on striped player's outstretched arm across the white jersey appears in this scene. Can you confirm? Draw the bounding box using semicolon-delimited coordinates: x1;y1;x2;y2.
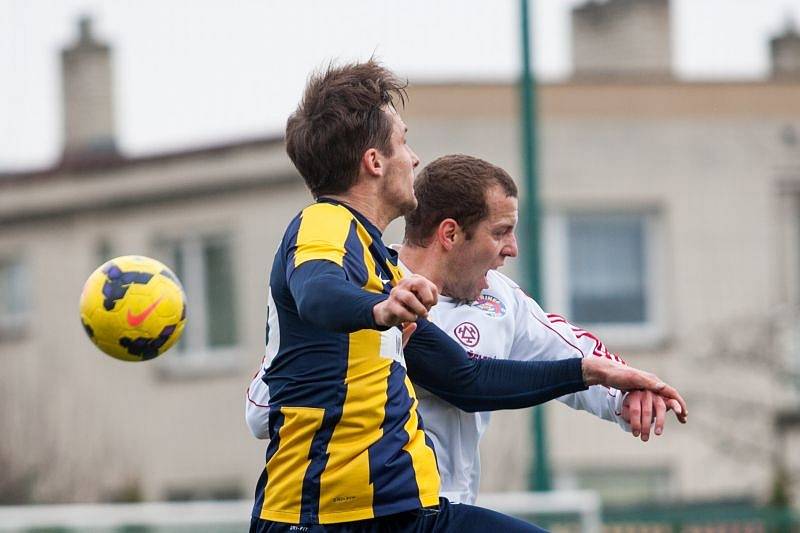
403;319;586;412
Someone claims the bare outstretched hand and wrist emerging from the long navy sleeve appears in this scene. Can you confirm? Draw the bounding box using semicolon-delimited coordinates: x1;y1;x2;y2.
581;357;689;424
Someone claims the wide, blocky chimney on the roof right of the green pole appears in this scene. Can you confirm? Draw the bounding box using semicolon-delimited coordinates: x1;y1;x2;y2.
572;0;672;78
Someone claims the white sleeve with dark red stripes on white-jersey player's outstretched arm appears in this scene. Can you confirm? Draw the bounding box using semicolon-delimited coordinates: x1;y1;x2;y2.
510;280;630;432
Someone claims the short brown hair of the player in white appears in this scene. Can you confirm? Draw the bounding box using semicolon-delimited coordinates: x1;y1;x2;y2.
404;154;517;247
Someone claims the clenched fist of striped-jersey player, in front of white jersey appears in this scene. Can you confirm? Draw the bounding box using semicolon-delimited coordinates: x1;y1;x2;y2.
372;274;439;327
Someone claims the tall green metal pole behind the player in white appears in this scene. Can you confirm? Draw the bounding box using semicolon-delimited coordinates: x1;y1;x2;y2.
520;0;551;490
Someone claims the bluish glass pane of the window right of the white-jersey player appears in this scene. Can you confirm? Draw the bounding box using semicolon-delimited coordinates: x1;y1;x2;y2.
567;215;647;323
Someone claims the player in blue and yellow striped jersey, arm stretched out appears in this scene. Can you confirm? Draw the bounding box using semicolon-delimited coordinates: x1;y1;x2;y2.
251;61;685;532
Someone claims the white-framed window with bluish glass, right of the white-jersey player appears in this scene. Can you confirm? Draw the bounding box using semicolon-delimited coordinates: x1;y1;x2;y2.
545;212;664;347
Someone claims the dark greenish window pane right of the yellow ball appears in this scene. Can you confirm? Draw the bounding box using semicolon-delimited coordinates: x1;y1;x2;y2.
203;239;236;348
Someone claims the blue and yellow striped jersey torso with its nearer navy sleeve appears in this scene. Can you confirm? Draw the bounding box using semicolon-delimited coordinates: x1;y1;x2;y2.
253;199;439;524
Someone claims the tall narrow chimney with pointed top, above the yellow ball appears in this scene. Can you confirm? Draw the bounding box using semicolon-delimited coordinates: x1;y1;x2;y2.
61;17;117;160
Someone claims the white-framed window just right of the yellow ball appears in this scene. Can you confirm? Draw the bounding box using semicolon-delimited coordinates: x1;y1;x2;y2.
157;235;238;366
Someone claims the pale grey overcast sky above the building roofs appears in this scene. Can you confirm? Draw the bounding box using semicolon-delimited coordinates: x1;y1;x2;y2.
0;0;800;170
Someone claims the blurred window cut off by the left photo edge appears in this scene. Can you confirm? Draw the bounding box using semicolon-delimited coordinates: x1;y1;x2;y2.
0;258;31;340
